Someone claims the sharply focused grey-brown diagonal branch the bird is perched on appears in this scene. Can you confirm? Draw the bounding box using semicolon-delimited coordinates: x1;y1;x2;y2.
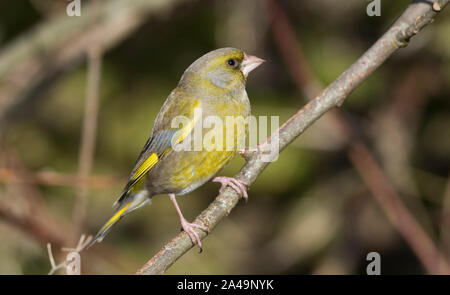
136;0;449;274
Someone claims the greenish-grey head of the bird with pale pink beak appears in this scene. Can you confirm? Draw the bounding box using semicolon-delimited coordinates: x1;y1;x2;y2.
181;47;264;90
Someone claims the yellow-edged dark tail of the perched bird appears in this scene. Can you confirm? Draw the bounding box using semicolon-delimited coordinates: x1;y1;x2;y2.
88;190;151;247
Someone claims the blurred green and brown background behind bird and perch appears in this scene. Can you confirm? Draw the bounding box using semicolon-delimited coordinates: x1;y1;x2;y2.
0;0;450;274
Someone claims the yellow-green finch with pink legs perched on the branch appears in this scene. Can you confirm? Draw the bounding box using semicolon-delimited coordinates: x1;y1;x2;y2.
89;47;264;251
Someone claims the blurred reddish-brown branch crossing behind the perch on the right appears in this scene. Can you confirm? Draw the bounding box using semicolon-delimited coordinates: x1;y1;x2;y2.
267;0;450;274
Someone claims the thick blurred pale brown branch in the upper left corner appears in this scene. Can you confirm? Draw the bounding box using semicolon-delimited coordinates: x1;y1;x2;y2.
0;0;185;132
